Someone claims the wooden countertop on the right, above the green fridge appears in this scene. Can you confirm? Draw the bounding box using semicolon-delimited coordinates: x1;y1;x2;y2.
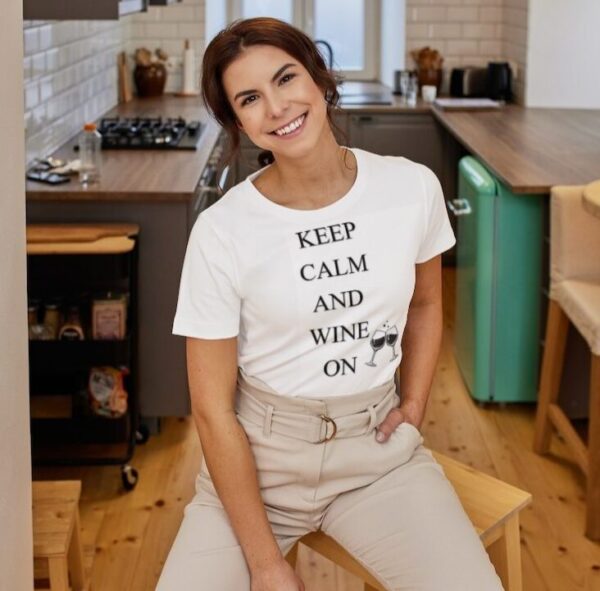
432;105;600;194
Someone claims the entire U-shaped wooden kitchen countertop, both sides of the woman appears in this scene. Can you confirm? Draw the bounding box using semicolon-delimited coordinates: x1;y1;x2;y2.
26;82;600;201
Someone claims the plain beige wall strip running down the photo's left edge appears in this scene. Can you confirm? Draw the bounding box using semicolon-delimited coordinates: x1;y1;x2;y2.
0;0;33;591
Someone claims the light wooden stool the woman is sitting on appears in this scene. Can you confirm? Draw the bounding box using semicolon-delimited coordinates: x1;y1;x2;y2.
286;452;531;591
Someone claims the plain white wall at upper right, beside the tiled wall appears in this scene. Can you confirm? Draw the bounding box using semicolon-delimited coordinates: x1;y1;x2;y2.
525;0;600;109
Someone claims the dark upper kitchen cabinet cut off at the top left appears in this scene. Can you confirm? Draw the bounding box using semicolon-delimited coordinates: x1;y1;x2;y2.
23;0;148;20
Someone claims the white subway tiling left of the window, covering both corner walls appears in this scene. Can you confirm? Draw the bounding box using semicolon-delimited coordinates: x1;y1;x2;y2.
23;0;205;165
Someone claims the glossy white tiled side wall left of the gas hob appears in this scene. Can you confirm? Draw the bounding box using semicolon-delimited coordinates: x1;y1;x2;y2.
23;17;126;163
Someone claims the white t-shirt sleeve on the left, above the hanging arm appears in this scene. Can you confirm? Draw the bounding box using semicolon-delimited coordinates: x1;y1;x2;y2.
173;215;241;339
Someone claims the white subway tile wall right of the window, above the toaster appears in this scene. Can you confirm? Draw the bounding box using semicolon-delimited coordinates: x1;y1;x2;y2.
406;0;528;103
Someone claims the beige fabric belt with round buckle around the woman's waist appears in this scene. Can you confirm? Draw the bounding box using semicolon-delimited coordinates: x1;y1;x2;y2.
236;372;400;443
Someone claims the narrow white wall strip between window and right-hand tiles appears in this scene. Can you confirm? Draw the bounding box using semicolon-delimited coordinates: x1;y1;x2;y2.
379;0;406;88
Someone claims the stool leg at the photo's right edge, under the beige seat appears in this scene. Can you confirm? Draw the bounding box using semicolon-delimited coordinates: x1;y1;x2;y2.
585;355;600;541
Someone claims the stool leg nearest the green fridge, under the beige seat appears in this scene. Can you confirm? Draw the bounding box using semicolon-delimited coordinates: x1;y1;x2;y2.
533;300;569;454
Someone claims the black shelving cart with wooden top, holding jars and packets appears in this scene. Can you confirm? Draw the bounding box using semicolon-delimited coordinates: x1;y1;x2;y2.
27;223;148;490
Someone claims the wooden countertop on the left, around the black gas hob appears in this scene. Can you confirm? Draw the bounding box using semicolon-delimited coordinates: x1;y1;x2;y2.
26;95;220;201
